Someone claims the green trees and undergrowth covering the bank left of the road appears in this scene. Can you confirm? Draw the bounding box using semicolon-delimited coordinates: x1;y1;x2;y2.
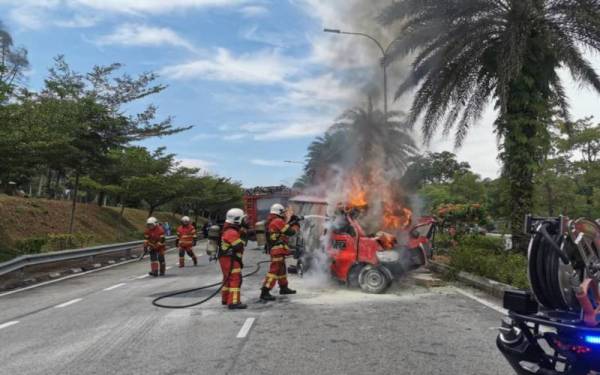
0;23;242;258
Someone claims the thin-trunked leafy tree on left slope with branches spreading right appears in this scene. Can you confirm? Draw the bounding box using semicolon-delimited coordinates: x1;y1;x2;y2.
40;56;189;233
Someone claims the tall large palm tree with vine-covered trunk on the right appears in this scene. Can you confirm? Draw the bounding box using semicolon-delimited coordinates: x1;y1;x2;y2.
381;0;600;250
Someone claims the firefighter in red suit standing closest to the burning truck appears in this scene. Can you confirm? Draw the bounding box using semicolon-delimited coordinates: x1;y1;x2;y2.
260;203;300;301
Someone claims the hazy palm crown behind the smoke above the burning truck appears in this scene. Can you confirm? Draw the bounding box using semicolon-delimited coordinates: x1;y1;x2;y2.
298;102;418;186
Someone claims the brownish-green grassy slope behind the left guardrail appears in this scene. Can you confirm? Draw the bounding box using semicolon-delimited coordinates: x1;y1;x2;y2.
0;195;177;261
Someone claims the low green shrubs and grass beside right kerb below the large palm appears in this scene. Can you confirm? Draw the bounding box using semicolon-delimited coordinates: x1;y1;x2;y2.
436;236;529;289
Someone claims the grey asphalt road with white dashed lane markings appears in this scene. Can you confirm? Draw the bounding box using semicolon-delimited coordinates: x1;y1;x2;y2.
0;242;512;375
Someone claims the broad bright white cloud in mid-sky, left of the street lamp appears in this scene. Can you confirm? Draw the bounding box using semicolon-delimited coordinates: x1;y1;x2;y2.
161;48;297;85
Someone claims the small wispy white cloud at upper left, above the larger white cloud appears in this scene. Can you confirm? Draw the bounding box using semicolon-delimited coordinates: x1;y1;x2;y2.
96;24;195;51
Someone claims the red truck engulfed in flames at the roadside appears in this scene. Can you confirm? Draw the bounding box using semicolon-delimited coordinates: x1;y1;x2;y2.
256;184;436;293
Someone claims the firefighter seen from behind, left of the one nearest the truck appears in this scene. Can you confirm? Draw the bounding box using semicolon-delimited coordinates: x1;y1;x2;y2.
219;208;247;310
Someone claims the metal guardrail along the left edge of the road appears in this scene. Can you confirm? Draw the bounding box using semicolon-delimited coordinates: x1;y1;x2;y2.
0;236;176;277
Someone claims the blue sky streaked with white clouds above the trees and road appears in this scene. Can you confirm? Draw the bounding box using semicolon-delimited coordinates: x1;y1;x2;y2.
0;0;600;186
